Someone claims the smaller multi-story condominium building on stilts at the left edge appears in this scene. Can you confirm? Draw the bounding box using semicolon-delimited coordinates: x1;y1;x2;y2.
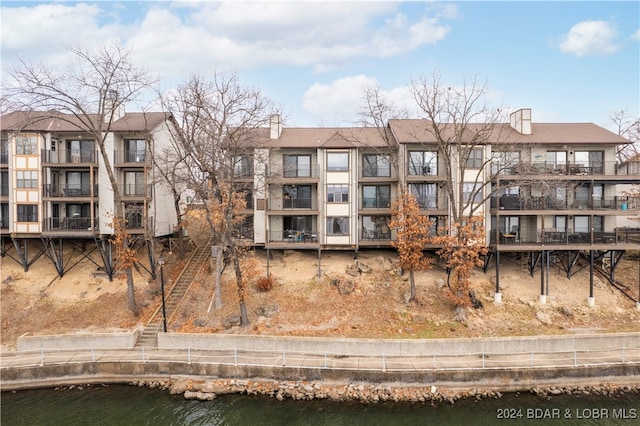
0;108;177;277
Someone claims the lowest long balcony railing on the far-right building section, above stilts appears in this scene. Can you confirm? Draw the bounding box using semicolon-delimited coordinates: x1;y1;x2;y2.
490;228;640;245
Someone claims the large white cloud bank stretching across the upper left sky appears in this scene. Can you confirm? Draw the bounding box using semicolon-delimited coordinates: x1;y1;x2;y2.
2;1;452;83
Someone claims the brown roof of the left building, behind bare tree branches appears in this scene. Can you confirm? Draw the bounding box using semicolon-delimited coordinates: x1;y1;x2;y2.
0;111;171;132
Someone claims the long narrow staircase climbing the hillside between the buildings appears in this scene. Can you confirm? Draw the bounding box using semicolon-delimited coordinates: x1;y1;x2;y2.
136;238;213;347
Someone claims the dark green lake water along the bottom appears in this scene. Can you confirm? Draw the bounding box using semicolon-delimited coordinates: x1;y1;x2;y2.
0;385;640;426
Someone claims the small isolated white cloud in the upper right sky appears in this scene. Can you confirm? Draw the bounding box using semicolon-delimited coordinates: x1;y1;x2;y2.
558;21;618;57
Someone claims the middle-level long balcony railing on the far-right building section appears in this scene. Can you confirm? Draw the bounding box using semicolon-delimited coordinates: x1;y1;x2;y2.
491;195;640;211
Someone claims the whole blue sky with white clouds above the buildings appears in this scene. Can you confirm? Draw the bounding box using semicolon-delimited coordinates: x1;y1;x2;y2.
0;0;640;128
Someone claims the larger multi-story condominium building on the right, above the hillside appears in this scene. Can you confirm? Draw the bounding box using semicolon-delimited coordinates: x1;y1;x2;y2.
235;109;640;300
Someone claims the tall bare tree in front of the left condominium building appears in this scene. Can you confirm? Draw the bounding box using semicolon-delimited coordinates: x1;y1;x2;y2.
6;44;155;312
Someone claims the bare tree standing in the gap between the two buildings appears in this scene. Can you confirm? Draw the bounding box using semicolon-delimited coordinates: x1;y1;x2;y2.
163;73;273;325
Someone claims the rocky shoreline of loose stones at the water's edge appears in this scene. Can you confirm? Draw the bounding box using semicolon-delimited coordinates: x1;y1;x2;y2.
125;379;640;404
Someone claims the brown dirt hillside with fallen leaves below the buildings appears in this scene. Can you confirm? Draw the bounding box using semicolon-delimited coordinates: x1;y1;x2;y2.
0;240;640;349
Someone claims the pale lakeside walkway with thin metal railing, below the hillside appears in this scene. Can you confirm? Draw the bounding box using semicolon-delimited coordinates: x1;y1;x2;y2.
0;346;640;372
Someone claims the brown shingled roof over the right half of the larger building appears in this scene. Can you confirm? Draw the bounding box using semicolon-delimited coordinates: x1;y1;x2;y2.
389;119;630;145
